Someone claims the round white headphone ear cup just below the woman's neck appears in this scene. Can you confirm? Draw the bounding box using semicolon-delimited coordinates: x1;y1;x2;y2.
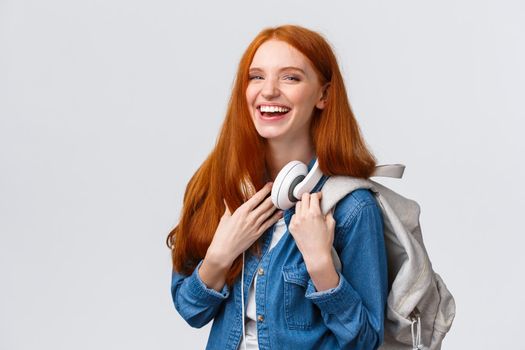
272;160;308;210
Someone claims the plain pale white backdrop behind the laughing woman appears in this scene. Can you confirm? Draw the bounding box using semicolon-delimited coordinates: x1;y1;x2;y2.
0;0;525;350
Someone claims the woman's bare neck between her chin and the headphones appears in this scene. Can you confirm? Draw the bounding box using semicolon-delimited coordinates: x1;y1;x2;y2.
266;137;315;181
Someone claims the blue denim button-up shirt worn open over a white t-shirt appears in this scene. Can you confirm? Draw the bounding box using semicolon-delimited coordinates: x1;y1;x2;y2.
171;159;388;350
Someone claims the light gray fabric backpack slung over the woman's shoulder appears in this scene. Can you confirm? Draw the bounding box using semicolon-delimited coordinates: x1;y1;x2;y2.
321;164;456;350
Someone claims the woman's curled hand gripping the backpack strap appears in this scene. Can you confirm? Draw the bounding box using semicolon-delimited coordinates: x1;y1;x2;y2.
288;192;335;267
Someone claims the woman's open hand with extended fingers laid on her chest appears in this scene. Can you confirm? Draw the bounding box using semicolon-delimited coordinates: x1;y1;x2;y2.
206;182;282;266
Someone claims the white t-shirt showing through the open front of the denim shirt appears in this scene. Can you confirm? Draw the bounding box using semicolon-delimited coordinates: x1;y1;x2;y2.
239;218;286;350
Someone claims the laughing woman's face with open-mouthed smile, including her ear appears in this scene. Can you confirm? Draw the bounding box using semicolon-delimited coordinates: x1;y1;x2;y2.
246;39;325;141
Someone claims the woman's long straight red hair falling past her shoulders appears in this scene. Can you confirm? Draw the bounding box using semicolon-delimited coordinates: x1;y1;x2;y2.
166;25;376;286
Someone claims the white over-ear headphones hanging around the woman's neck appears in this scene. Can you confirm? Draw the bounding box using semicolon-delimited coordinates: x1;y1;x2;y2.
272;159;323;210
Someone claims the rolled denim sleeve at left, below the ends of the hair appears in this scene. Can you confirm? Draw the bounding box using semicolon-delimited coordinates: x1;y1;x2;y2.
171;260;230;328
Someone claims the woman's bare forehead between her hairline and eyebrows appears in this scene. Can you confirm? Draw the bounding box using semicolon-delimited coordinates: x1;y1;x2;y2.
250;39;313;72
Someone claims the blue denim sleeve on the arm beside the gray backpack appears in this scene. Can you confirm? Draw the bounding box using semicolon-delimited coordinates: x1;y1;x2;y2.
305;201;388;350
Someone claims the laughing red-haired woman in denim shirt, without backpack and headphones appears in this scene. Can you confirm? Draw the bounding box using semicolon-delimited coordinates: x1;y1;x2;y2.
167;25;388;350
